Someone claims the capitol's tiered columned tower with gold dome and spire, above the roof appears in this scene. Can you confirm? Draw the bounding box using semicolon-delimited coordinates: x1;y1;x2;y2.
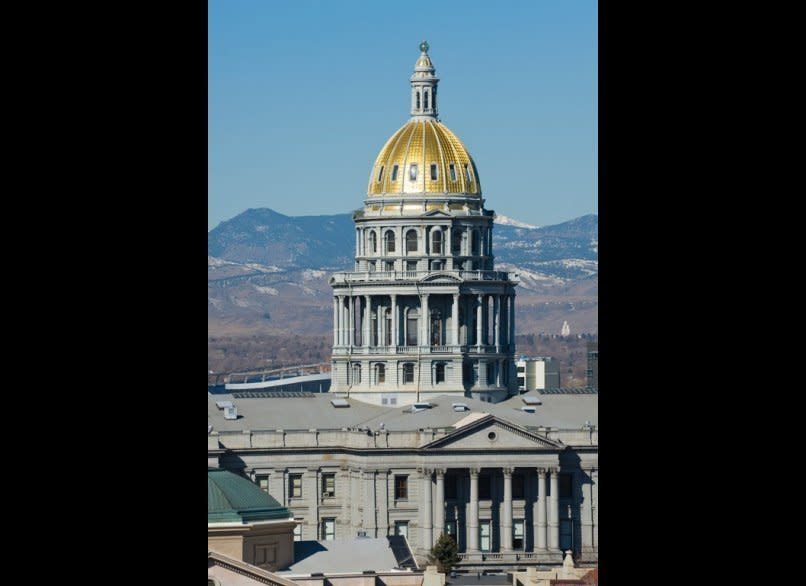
331;42;517;405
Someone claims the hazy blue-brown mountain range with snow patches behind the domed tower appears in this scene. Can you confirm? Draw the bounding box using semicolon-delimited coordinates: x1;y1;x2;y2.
207;208;598;336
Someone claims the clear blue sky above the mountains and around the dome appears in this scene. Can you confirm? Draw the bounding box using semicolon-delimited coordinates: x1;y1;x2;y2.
207;0;598;229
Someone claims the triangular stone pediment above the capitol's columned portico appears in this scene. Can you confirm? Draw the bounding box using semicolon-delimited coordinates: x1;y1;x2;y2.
423;415;565;450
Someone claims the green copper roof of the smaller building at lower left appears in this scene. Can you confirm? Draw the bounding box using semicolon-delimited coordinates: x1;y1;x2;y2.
207;468;291;523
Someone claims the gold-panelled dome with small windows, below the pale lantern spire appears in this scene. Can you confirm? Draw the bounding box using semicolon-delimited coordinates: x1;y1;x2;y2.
367;119;481;196
